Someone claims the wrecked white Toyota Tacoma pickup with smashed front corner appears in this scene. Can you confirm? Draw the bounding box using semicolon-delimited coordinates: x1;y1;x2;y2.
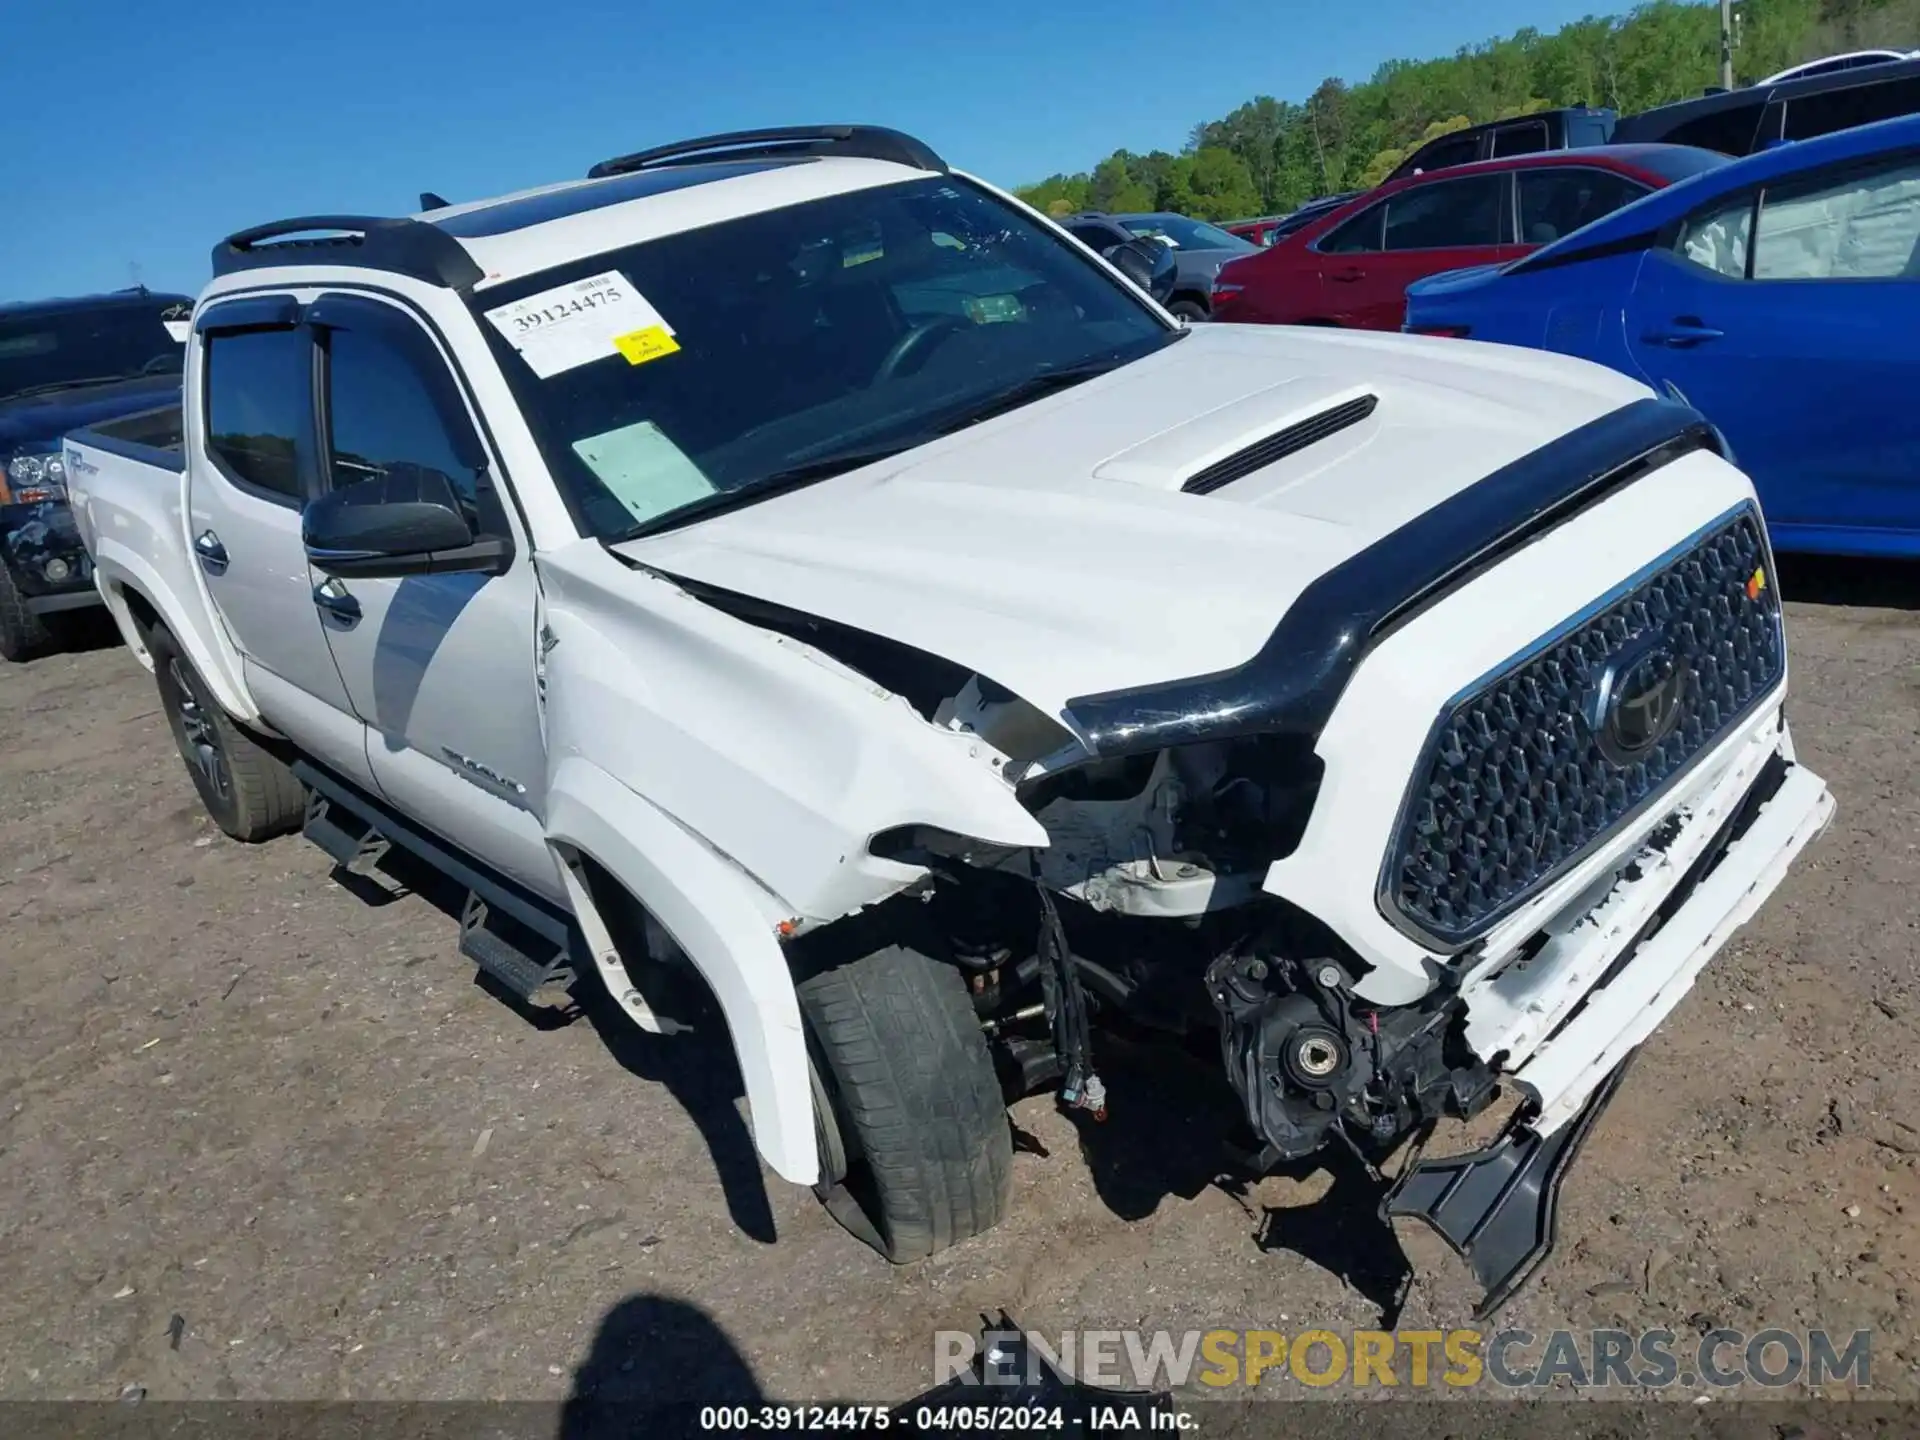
65;127;1832;1308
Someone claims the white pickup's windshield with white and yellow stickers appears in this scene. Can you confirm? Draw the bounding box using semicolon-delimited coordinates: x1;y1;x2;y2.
472;179;1185;540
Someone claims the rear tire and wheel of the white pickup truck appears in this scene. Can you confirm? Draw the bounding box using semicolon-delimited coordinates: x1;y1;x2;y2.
146;626;307;845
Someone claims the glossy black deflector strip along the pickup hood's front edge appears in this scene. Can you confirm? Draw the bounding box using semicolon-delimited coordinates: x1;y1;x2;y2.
1064;399;1726;758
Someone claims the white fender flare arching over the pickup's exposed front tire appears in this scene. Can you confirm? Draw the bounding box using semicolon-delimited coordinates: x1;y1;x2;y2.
545;756;820;1185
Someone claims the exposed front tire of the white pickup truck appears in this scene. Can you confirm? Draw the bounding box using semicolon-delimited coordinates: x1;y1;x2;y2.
799;947;1014;1263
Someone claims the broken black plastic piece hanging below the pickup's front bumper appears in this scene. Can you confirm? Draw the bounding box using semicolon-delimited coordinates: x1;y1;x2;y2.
1380;1052;1638;1321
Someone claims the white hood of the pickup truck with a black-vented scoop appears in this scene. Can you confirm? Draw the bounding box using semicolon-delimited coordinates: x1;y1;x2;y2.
614;324;1649;716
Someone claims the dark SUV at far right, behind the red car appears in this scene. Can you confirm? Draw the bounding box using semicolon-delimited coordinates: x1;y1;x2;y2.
1613;60;1920;156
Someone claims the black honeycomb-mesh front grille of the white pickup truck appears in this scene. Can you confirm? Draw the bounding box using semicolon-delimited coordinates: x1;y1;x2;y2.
1382;511;1786;945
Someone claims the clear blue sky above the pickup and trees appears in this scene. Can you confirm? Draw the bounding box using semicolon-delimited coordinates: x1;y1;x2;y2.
0;0;1605;300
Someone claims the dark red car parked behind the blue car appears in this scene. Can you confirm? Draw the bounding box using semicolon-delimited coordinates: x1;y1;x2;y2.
1213;144;1728;330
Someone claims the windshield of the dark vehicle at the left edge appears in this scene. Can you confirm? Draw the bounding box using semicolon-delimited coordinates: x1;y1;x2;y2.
0;298;194;399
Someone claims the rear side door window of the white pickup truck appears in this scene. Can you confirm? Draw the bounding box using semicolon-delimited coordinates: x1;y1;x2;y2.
204;328;313;503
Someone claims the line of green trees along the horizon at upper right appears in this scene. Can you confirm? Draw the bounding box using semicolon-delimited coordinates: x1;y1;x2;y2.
1020;0;1920;219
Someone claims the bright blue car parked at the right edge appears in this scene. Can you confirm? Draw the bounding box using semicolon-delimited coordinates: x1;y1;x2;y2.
1405;115;1920;555
